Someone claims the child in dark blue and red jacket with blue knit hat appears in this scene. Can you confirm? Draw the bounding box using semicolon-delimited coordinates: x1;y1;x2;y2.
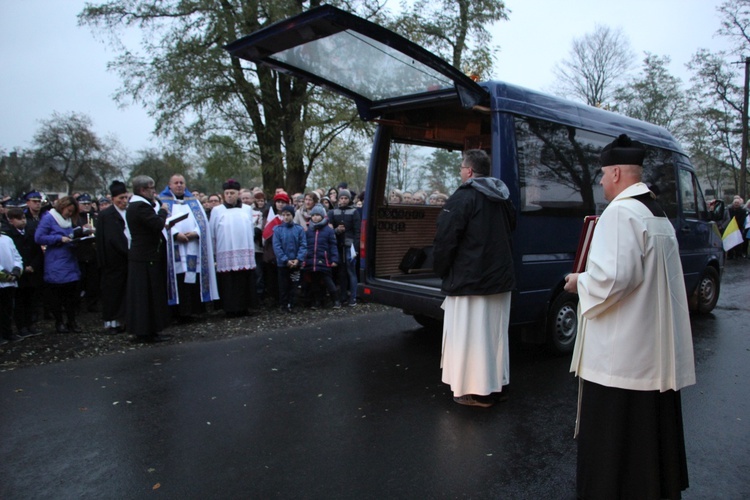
304;205;341;309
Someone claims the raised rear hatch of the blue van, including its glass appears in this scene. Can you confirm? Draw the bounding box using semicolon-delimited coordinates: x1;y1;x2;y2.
225;5;489;120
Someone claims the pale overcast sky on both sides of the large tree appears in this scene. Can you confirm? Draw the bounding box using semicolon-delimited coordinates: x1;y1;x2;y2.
0;0;740;153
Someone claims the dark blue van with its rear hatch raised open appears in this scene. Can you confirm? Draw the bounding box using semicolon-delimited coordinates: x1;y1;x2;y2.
226;6;724;353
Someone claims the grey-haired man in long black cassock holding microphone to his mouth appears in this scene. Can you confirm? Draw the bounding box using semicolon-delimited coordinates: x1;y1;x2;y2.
126;175;172;342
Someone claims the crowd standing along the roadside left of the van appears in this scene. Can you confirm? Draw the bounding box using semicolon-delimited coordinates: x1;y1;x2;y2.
0;174;364;345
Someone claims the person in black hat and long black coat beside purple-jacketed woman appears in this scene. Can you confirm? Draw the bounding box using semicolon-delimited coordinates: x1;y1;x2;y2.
96;181;129;334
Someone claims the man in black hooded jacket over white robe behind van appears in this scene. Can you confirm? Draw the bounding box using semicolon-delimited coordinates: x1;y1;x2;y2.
433;149;515;407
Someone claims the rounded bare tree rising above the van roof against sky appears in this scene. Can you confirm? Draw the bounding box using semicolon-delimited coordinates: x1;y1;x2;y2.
555;25;635;107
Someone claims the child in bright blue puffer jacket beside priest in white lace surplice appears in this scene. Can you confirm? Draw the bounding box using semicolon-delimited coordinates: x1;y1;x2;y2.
273;205;307;313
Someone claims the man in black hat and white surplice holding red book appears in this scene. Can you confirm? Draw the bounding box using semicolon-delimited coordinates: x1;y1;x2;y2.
565;134;695;498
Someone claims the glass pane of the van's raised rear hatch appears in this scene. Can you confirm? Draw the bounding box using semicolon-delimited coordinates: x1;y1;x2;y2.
270;30;453;101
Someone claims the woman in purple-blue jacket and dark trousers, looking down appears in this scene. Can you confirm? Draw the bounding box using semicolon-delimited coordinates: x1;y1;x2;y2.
34;196;88;333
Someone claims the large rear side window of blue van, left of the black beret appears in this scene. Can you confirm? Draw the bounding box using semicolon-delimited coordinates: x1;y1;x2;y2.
515;116;612;217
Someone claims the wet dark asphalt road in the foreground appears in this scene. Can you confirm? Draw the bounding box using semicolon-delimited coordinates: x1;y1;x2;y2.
0;262;750;500
